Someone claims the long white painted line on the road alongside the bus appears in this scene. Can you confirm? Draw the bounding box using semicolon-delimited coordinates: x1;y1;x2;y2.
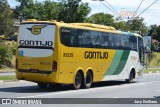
17;81;160;98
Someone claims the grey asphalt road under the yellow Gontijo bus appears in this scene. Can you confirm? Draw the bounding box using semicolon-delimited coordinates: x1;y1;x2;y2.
0;73;160;107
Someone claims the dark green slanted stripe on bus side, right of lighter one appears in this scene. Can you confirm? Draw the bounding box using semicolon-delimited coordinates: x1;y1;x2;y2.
113;50;130;75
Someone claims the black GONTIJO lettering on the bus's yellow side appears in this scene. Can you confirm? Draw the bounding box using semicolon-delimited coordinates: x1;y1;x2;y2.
84;51;108;59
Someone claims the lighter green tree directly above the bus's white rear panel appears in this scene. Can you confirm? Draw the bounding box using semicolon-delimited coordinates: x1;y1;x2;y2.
19;1;59;20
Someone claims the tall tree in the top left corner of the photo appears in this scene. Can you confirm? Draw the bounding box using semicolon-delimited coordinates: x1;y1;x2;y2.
0;0;14;35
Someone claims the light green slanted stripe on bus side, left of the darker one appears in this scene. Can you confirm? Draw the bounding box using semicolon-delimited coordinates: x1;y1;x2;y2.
105;50;123;75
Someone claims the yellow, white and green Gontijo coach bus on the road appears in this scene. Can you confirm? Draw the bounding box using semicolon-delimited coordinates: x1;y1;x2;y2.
16;19;144;89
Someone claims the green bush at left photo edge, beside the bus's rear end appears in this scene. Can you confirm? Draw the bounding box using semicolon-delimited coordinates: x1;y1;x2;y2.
0;42;13;65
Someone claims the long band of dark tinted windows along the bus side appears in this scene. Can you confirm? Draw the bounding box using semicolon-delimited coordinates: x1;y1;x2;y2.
61;28;137;50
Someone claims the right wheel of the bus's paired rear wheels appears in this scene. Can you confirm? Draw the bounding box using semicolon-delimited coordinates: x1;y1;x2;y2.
83;72;93;88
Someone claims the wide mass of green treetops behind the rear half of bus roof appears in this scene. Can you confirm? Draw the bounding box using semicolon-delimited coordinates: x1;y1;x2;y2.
14;0;90;22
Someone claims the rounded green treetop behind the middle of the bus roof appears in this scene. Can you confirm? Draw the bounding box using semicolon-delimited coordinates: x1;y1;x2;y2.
87;13;114;26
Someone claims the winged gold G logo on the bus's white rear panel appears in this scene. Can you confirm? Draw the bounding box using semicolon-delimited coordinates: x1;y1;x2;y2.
27;25;46;35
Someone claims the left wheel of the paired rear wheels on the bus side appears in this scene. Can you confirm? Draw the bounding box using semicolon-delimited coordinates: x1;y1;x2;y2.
73;72;82;89
